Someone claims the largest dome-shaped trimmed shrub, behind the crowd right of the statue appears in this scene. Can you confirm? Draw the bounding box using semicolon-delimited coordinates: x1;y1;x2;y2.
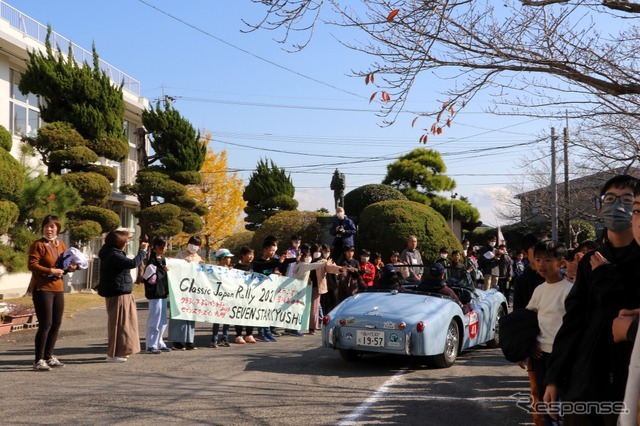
358;200;462;264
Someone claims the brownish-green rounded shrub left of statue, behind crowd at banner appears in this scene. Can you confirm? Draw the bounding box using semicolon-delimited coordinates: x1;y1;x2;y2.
251;210;328;248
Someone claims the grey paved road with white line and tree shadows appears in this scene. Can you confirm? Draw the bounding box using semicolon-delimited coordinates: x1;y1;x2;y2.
0;302;532;425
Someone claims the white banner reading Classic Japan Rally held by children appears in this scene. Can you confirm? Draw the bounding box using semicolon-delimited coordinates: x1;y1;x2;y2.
167;259;324;330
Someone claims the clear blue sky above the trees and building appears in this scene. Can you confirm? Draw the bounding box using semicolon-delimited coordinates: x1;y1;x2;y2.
7;0;563;225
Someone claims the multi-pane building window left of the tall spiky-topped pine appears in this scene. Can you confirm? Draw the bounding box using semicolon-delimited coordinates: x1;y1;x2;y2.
9;70;42;137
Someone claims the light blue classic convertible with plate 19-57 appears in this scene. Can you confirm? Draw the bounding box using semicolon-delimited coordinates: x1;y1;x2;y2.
322;274;507;368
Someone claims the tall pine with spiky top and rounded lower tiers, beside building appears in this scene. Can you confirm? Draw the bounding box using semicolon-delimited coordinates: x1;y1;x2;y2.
19;28;129;240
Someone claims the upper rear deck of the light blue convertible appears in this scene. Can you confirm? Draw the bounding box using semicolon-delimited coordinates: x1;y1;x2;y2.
329;292;455;320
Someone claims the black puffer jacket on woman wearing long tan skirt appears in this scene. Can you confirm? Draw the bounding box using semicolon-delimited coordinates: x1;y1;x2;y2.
98;245;147;297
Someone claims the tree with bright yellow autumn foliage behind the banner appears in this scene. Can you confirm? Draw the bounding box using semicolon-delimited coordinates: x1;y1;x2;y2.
173;134;246;256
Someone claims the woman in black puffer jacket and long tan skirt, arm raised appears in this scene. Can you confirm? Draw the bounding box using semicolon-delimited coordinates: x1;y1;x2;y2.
98;230;149;362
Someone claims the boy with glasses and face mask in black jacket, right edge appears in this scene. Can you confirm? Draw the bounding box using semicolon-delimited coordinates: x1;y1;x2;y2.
544;175;640;425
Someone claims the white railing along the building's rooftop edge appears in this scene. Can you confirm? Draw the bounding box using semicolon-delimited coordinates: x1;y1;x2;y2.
0;1;140;96
